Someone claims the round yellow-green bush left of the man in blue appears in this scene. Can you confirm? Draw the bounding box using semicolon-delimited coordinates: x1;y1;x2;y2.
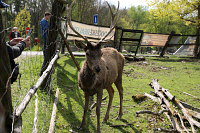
15;8;31;33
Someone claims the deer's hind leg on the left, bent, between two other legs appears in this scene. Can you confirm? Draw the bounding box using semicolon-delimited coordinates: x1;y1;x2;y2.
103;86;114;122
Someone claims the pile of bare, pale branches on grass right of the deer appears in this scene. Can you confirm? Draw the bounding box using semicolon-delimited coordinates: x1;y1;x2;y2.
136;80;200;133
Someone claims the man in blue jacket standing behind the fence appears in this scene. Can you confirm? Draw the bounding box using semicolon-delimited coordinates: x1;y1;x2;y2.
40;12;51;52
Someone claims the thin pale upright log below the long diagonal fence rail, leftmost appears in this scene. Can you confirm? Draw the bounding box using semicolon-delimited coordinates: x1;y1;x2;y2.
32;92;38;133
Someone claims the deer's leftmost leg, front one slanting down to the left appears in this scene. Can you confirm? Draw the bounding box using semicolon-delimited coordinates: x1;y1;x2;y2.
79;93;89;129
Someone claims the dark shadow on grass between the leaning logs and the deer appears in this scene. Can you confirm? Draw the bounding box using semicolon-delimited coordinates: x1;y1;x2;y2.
56;58;96;132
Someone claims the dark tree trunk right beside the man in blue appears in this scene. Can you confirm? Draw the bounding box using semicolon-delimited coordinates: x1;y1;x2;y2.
41;0;66;89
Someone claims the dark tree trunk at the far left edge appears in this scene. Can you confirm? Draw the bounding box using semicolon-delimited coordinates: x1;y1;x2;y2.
0;11;12;132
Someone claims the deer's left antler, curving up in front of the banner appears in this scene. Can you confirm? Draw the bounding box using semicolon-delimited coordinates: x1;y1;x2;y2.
67;0;89;43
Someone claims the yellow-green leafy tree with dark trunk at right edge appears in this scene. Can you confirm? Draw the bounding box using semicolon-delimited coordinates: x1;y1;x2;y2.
146;0;200;55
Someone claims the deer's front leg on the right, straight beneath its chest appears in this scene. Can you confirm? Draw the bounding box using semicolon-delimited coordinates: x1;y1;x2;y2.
96;89;103;133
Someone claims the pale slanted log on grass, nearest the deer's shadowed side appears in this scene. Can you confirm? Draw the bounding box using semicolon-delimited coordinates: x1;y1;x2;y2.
48;88;59;133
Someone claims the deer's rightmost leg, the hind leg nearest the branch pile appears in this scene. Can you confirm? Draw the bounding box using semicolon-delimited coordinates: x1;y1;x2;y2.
115;76;123;119
